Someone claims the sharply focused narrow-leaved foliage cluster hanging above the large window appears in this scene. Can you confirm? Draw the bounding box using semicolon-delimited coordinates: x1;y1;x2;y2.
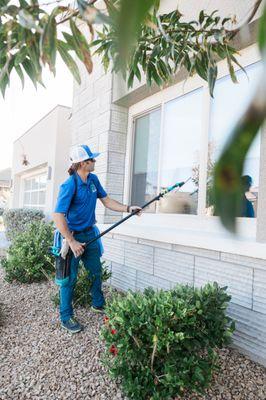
92;7;239;95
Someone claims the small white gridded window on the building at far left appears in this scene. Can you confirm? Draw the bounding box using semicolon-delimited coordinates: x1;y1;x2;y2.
23;173;46;210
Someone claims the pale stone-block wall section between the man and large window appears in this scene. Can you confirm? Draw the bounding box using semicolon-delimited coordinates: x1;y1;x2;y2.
71;57;128;223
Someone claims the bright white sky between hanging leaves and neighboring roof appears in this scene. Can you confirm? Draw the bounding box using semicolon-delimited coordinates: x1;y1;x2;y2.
0;60;73;170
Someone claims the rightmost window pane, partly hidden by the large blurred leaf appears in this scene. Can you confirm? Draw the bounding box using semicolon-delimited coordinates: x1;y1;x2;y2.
206;63;261;216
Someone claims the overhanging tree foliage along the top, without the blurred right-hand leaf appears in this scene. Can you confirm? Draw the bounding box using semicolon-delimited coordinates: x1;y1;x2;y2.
0;0;245;96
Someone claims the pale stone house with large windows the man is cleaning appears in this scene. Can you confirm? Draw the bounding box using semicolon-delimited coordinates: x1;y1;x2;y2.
71;0;266;364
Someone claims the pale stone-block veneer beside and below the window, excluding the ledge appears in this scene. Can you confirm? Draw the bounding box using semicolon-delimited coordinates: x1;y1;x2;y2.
71;22;266;365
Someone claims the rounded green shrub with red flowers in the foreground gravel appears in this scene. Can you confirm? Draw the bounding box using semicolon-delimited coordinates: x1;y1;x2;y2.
101;283;234;400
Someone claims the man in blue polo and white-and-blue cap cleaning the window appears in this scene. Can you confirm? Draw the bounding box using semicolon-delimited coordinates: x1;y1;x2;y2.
53;145;141;333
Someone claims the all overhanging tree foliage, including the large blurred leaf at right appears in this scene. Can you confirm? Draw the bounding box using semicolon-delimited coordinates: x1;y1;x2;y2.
0;0;266;231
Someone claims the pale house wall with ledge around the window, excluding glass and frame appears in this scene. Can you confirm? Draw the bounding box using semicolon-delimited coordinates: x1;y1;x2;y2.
72;1;266;365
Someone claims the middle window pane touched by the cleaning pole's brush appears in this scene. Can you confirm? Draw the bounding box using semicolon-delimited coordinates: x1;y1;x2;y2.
159;89;203;214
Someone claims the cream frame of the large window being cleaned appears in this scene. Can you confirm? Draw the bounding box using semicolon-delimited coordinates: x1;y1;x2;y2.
124;44;261;237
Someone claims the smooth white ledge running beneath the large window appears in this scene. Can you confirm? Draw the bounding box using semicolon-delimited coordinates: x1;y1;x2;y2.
98;214;266;260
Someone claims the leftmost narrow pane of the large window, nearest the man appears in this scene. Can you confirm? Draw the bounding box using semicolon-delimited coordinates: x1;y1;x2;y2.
131;109;161;211
